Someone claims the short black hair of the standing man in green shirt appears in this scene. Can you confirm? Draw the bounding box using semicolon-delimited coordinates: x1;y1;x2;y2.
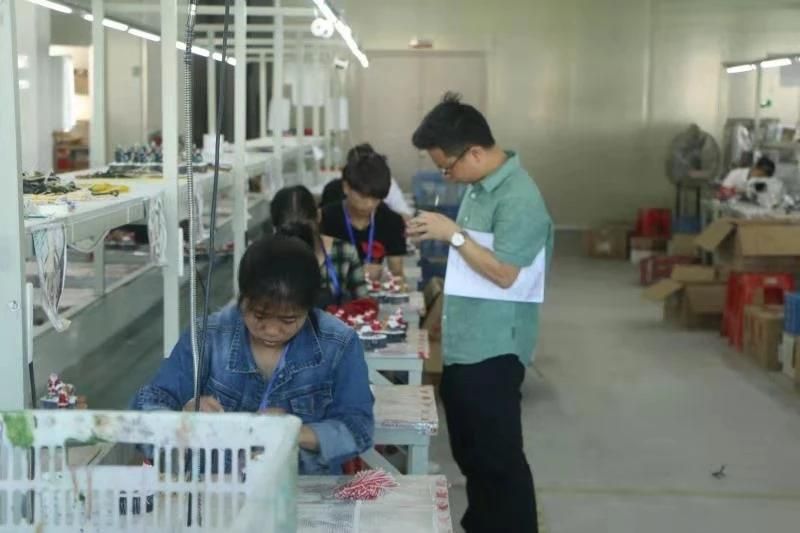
411;92;495;156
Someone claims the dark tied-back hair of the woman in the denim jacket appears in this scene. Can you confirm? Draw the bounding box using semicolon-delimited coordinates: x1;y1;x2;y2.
239;235;321;311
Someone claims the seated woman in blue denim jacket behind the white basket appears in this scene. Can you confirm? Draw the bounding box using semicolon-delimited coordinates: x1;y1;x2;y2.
133;236;374;474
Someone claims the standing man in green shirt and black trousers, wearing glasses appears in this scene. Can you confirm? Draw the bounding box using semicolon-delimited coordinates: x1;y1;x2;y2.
408;94;553;533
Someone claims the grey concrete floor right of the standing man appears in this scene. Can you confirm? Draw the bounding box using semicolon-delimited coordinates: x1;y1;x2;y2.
432;236;800;533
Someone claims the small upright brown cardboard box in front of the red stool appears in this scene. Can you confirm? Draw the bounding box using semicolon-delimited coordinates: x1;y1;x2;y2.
744;305;783;371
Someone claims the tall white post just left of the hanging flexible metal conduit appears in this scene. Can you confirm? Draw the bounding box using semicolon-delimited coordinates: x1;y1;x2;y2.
161;0;183;357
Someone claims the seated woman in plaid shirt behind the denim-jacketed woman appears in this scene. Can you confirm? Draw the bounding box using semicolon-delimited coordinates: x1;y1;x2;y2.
270;185;367;309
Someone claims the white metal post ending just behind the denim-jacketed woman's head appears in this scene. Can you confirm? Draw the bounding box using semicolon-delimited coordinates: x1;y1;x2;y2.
233;0;248;294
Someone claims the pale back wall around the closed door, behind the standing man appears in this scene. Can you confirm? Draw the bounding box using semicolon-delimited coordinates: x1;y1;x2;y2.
337;0;800;226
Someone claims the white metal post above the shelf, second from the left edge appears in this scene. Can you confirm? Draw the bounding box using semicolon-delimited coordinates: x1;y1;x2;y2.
89;0;107;168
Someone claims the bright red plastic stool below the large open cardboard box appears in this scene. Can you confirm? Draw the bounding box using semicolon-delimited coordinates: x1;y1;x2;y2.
722;273;795;351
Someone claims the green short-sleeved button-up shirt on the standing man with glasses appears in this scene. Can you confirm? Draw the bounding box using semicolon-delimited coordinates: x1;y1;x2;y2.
442;152;553;366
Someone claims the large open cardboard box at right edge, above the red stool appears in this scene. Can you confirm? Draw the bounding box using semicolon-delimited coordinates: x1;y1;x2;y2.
695;219;800;272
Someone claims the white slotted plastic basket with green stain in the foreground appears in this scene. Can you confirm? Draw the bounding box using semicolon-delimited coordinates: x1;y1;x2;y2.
0;410;300;533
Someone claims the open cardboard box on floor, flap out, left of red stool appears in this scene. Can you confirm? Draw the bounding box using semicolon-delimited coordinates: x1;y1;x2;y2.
644;265;727;329
